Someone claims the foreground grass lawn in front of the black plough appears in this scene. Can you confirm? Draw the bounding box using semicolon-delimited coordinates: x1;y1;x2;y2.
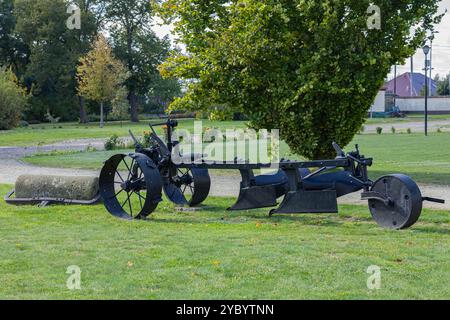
0;185;450;299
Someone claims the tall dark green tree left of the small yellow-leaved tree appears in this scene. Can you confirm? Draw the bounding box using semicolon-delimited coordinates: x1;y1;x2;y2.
14;0;97;120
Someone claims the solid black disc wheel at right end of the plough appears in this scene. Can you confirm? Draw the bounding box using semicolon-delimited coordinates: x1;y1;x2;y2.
369;174;422;230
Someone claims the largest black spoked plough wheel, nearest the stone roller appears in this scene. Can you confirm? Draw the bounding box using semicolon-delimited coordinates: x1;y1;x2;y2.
99;154;162;220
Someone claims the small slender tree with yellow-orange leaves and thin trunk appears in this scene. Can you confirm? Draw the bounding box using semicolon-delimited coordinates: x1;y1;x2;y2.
77;35;129;128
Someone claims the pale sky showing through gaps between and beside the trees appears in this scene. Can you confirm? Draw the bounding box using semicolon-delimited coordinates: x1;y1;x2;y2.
154;0;450;79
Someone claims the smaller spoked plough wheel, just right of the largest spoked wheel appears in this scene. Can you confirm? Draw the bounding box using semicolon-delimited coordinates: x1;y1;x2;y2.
164;166;211;207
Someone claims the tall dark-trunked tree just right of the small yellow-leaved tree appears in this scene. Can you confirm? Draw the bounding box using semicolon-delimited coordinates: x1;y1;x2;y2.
106;0;181;122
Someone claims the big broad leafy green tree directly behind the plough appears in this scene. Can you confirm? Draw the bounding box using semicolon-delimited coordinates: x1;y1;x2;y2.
155;0;441;158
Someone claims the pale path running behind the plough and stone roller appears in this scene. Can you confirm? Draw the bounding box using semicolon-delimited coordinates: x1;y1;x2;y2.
0;139;450;210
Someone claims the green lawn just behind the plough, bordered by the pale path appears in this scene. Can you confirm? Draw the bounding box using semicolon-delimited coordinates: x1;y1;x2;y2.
24;133;450;185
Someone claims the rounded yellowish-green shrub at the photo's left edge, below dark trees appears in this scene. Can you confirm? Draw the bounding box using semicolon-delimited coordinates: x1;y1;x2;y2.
0;69;27;130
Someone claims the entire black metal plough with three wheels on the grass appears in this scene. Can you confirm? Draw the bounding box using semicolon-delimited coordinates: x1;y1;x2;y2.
100;119;444;229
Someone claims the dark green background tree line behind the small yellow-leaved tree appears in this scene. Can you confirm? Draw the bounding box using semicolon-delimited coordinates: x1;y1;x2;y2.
0;0;181;123
